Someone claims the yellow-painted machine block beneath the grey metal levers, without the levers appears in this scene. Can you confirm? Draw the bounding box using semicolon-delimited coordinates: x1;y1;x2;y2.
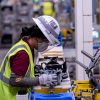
73;80;100;100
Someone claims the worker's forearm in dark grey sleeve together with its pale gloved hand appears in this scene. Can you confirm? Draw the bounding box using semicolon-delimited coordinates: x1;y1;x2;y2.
10;74;57;87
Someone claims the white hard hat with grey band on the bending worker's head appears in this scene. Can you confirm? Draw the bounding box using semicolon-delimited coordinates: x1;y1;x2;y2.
33;15;60;45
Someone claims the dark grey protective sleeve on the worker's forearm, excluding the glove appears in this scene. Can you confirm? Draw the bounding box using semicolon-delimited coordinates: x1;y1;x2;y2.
10;74;39;87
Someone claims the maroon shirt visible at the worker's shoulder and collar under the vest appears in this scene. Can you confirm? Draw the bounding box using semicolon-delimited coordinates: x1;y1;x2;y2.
10;39;33;76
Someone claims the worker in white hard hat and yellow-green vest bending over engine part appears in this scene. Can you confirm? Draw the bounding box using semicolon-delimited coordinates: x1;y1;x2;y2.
0;15;60;100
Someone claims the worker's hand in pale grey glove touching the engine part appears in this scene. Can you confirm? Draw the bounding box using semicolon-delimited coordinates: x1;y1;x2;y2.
39;74;57;85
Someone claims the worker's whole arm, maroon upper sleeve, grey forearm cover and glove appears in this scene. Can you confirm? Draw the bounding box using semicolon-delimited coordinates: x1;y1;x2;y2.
10;48;55;87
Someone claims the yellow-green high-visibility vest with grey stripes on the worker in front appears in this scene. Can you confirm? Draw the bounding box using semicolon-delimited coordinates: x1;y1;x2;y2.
0;40;34;100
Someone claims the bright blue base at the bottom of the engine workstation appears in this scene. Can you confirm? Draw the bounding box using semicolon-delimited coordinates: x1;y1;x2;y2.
29;92;75;100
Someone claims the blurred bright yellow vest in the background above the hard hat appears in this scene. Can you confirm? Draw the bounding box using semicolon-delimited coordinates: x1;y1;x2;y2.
43;2;54;16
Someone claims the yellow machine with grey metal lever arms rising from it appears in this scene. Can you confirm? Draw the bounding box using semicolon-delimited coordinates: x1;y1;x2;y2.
73;49;100;100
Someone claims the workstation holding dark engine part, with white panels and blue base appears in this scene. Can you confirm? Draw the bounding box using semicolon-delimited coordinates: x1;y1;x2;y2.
29;46;74;100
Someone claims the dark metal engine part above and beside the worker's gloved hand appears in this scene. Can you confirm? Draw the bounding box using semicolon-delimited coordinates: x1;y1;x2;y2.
35;57;68;85
